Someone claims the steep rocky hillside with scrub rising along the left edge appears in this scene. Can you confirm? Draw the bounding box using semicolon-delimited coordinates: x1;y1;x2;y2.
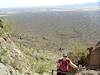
0;20;30;75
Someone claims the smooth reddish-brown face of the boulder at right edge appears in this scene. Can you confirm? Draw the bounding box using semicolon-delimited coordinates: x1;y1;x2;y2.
87;46;100;69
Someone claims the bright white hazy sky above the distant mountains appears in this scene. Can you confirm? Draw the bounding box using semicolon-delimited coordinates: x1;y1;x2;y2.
0;0;100;8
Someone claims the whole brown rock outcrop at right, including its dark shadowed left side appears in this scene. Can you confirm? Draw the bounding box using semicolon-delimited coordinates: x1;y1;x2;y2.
78;42;100;70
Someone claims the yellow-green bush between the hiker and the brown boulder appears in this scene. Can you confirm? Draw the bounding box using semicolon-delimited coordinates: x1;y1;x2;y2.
68;42;87;63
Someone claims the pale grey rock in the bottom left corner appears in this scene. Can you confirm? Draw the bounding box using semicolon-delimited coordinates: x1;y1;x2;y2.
0;63;17;75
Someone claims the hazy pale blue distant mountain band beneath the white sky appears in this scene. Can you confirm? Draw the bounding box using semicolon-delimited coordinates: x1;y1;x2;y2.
0;2;100;14
